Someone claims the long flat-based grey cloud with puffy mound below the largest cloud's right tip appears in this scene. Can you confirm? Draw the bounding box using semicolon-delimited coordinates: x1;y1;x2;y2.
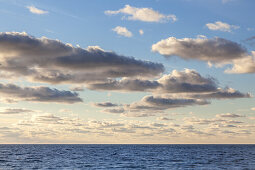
86;69;251;99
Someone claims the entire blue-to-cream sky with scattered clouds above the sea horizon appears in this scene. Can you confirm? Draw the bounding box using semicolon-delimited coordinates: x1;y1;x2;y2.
0;0;255;144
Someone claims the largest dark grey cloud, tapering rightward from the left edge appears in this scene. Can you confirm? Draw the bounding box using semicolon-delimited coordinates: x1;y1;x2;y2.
0;32;164;84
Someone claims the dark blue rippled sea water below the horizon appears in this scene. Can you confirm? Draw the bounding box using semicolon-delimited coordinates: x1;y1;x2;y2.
0;145;255;169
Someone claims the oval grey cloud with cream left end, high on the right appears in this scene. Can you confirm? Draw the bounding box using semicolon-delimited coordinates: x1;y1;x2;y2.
152;37;247;64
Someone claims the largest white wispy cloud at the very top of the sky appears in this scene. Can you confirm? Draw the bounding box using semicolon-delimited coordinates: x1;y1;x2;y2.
105;5;177;22
